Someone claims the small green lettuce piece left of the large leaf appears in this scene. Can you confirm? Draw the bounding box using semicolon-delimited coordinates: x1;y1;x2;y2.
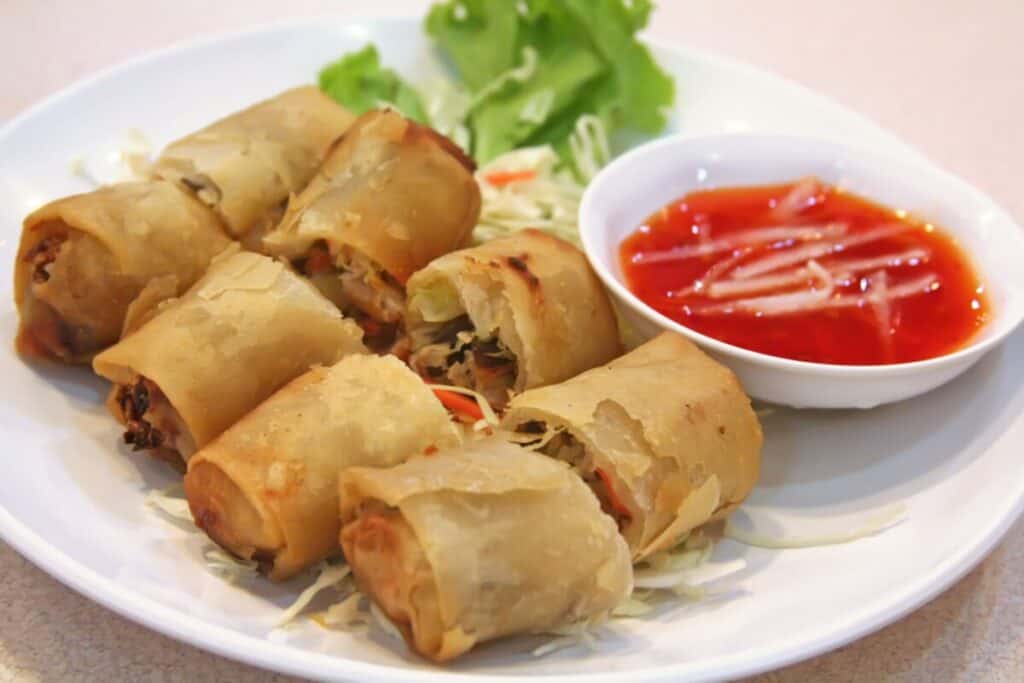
319;45;429;124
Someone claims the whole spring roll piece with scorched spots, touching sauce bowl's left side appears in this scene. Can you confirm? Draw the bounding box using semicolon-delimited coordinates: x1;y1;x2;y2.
406;230;622;410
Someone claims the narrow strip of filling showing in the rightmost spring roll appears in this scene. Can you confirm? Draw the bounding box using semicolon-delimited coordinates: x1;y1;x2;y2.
515;420;633;530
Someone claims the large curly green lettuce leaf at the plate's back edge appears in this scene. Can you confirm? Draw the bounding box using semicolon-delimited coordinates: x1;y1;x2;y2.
426;0;675;164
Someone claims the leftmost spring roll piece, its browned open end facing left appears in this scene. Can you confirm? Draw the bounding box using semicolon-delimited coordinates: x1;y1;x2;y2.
14;181;229;362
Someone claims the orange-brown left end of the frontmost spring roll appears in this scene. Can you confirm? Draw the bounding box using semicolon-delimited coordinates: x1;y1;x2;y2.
341;501;444;655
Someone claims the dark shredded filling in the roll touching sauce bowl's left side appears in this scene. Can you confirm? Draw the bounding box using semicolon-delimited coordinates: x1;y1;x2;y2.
409;314;517;411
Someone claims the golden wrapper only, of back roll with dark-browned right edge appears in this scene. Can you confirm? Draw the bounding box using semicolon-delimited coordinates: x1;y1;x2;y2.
263;111;480;283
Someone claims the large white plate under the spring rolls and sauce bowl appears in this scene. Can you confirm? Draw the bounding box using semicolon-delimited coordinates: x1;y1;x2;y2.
0;18;1024;681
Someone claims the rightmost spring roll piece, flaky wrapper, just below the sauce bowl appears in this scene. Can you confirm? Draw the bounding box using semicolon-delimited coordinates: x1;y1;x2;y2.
502;333;762;560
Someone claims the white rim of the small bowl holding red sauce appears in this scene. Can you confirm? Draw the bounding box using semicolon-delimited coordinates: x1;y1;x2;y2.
579;132;1024;377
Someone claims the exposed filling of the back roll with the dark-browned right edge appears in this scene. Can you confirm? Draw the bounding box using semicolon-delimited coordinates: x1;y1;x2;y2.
296;241;406;352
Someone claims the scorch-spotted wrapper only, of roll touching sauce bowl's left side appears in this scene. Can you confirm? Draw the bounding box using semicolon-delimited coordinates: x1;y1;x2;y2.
406;229;622;392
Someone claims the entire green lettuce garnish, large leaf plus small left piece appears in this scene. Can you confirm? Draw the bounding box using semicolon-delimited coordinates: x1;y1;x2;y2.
319;0;676;180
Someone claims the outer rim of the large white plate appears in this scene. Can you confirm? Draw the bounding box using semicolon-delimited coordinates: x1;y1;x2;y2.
0;13;1024;683
